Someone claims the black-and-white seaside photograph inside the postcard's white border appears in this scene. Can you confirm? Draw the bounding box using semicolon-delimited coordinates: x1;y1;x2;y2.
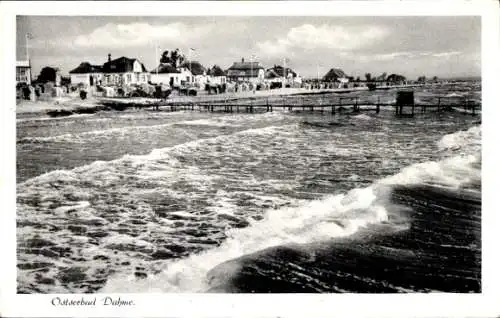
3;2;498;316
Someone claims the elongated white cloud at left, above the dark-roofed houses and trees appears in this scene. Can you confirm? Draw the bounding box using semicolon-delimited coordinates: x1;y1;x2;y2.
39;22;210;48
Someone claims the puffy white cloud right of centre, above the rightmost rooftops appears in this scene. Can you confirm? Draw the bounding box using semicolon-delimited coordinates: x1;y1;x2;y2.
257;24;389;56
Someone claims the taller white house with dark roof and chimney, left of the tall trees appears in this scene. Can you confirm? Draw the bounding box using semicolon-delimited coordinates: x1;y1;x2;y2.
102;54;151;85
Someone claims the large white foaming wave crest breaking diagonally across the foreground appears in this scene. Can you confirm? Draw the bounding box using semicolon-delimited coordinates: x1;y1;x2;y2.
100;127;481;292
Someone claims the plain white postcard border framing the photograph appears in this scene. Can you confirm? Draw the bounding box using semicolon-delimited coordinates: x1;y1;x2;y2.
0;0;500;317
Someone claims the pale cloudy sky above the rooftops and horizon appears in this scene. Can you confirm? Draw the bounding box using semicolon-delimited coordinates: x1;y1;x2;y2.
16;16;481;79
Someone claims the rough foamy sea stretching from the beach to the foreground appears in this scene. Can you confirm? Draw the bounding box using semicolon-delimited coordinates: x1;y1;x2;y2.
16;82;481;293
